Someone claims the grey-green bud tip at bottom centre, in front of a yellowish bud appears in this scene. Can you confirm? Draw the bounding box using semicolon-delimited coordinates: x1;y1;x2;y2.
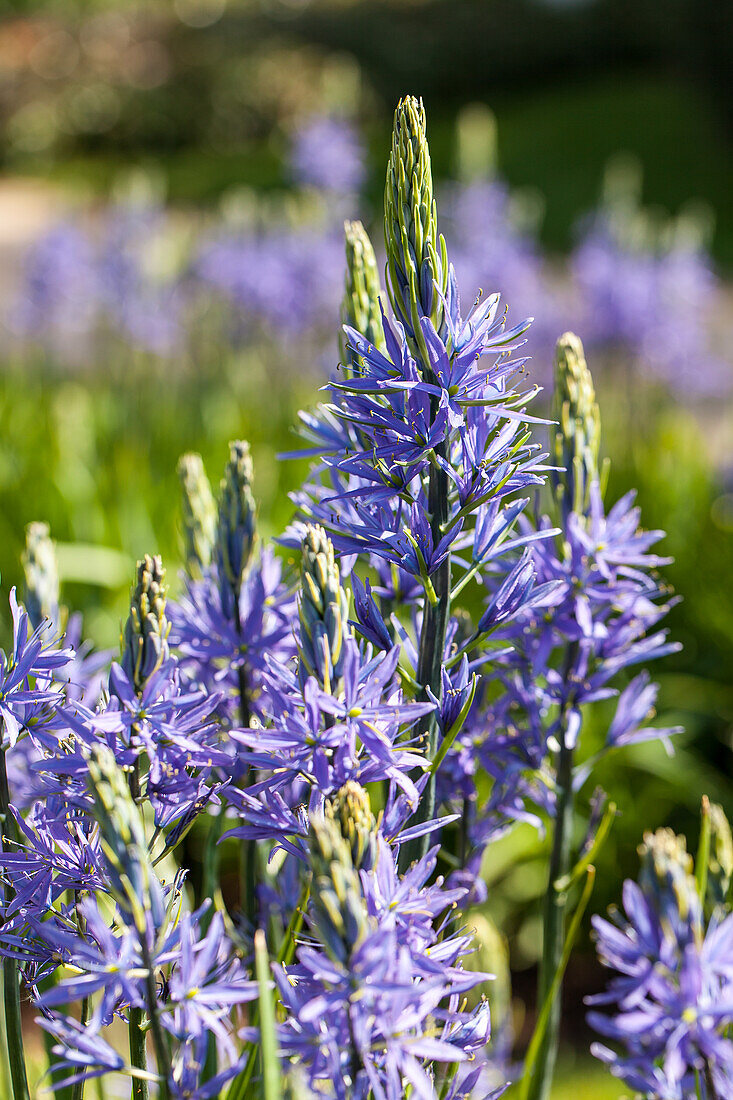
308;815;369;963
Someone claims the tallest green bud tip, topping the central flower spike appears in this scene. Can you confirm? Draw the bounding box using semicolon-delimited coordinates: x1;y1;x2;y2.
384;96;448;365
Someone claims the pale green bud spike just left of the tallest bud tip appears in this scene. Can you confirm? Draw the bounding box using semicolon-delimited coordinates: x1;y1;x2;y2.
341;221;384;367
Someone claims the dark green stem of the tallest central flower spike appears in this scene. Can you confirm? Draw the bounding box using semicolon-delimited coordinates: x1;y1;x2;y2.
401;444;450;870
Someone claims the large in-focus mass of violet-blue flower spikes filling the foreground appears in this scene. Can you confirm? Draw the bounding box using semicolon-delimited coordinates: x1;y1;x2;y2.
0;97;695;1100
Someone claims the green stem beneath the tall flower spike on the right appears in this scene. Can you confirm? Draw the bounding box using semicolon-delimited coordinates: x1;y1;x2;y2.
529;704;573;1100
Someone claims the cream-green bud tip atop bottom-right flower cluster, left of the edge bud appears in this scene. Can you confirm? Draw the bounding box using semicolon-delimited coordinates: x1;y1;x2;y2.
638;828;702;928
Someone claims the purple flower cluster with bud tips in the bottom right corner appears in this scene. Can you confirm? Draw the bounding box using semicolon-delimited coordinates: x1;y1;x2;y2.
588;805;733;1100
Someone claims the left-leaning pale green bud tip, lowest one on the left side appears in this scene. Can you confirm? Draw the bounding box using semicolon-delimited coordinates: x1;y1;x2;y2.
87;744;164;931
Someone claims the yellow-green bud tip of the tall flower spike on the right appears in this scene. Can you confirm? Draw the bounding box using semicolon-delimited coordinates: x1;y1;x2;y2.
551;332;601;518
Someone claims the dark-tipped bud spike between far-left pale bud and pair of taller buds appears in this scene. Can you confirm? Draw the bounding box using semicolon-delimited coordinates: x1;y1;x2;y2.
121;554;171;694
